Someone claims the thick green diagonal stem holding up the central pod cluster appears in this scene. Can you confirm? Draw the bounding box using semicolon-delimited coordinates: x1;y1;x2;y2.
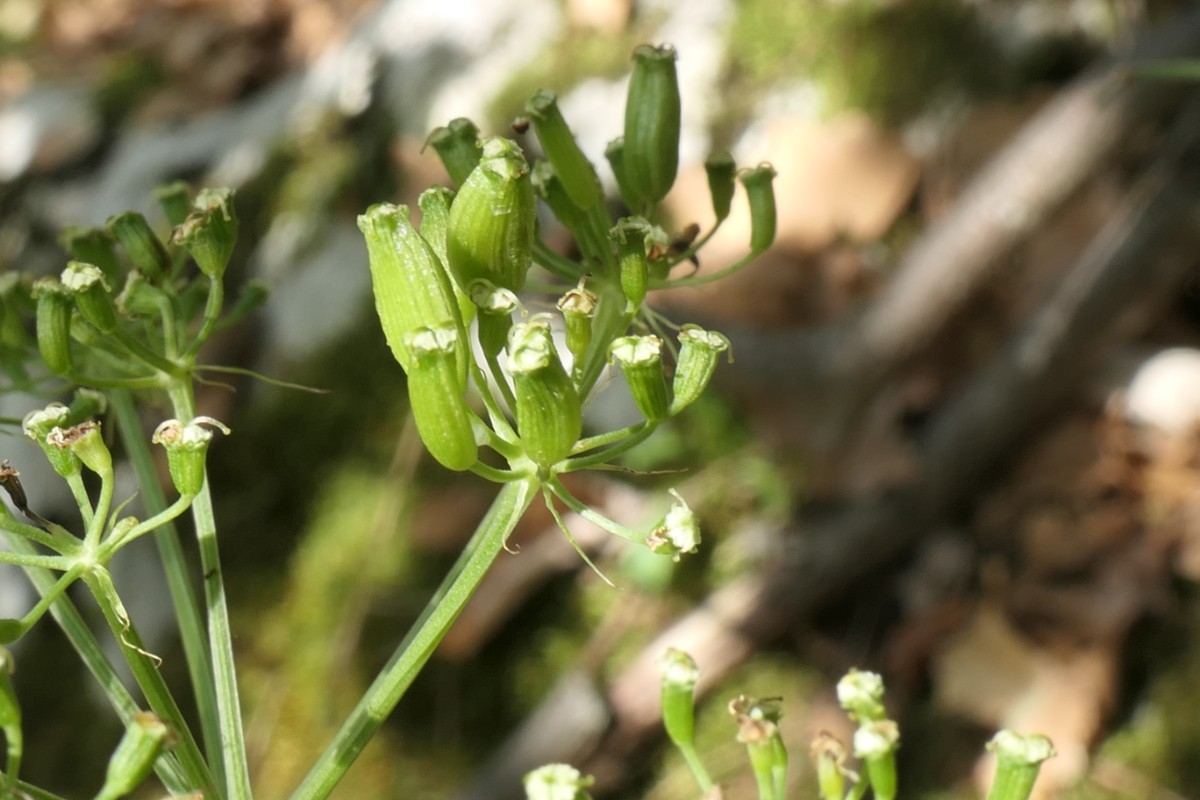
292;479;538;800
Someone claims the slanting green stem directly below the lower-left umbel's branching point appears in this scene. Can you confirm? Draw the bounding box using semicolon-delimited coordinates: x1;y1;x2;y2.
83;567;218;798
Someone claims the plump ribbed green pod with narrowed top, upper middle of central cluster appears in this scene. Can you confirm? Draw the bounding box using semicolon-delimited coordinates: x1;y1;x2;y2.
446;137;536;291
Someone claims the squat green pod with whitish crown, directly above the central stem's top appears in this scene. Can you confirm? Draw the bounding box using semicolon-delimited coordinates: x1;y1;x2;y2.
508;319;583;469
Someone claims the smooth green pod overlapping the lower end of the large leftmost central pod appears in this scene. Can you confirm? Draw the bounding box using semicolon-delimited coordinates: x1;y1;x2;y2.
404;325;479;471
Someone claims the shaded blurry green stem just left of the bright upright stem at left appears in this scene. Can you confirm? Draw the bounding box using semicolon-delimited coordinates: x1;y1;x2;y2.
108;391;224;784
